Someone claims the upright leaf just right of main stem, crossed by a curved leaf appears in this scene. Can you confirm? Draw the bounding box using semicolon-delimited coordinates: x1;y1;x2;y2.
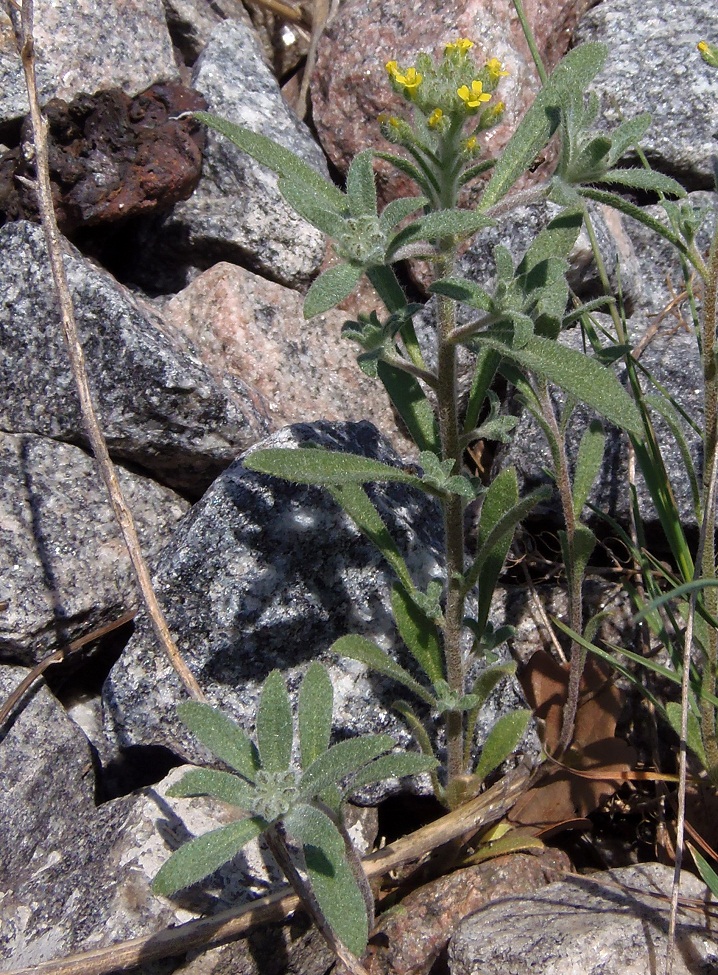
476;467;519;632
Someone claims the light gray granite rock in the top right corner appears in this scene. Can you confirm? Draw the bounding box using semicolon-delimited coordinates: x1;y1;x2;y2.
576;0;718;189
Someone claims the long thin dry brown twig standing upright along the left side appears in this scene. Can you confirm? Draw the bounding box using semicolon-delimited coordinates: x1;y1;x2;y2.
7;0;205;701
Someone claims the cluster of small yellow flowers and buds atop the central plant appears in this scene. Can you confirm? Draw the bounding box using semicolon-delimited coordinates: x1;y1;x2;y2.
379;37;509;156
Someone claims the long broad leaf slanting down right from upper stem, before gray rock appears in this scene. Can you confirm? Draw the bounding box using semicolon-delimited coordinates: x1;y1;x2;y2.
481;333;643;437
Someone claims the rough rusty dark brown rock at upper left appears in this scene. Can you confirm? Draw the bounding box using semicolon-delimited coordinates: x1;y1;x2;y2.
0;82;206;234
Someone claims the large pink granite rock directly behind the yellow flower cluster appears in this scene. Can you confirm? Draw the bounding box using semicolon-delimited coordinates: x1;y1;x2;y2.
312;0;591;202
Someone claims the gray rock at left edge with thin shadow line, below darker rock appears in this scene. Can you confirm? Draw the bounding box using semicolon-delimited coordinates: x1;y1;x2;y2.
0;433;189;664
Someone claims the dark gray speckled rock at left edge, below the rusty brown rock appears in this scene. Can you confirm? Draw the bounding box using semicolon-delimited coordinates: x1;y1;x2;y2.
0;222;265;496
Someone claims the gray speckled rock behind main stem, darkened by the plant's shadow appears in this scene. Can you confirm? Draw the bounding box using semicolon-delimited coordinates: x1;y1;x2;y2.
104;423;442;796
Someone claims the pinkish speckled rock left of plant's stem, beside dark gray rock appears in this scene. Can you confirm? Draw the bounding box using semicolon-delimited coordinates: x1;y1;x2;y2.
163;263;414;452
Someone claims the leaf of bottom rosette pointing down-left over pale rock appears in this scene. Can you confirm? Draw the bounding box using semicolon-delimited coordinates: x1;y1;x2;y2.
152;817;269;896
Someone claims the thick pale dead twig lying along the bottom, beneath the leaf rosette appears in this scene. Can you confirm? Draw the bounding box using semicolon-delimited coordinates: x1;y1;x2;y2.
0;766;531;975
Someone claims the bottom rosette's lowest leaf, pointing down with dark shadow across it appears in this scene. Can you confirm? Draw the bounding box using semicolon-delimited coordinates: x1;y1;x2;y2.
286;805;369;958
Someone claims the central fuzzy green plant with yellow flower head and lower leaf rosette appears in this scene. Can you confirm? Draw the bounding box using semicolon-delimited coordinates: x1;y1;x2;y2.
156;30;683;954
